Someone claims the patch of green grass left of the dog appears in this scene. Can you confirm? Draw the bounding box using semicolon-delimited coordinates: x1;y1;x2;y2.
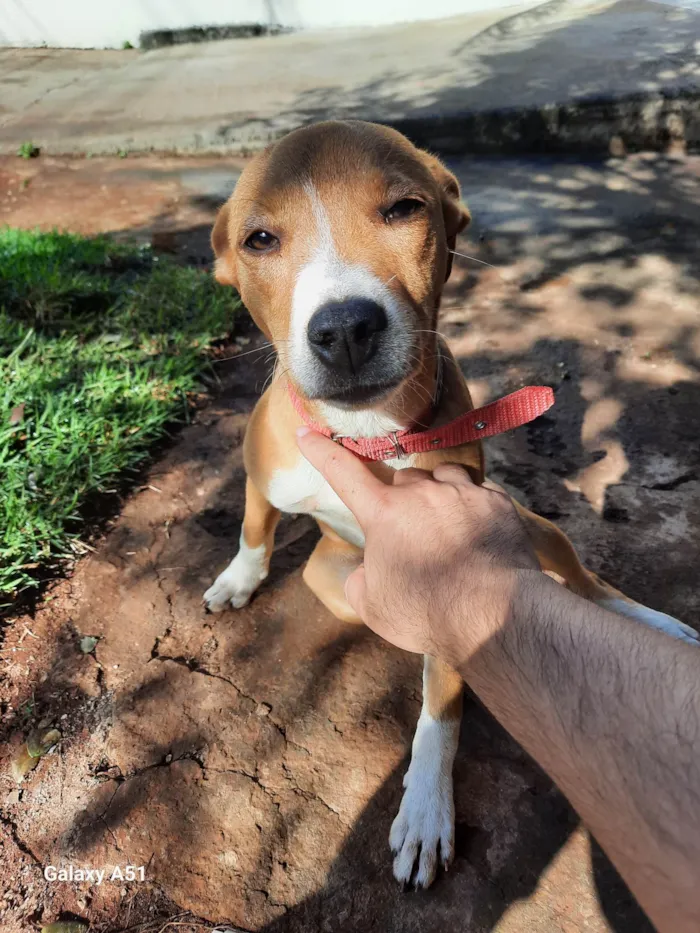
0;228;239;597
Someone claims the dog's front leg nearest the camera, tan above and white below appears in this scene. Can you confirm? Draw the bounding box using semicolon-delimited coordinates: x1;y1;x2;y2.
389;655;463;888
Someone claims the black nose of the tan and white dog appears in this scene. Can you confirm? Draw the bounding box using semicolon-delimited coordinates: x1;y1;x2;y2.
307;298;388;375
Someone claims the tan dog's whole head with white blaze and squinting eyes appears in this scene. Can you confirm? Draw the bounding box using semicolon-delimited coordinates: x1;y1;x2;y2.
212;122;469;408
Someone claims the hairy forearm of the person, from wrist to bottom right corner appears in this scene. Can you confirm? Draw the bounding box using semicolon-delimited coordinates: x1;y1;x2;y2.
454;571;700;933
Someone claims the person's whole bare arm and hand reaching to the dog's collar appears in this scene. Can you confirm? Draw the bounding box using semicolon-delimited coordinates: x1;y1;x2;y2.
300;433;700;933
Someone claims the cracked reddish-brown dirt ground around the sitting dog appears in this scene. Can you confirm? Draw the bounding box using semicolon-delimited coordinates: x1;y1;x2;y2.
0;156;700;933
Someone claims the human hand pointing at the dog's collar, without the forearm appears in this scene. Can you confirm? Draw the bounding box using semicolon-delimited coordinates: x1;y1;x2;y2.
297;428;539;662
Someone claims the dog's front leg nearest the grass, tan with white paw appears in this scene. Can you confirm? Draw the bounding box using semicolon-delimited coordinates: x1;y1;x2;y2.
204;477;280;612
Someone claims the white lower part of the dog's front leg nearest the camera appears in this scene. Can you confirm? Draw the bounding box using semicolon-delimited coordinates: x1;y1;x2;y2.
389;715;459;888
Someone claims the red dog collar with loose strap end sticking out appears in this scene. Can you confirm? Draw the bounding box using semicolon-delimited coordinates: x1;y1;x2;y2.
287;383;554;460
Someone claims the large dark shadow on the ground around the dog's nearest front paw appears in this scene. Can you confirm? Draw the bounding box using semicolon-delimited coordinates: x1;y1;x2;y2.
247;699;653;933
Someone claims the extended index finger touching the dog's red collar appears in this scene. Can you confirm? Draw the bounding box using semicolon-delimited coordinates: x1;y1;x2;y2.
297;428;386;527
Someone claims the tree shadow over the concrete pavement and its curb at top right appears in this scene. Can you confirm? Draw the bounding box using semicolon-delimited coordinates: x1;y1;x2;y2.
211;0;700;154
